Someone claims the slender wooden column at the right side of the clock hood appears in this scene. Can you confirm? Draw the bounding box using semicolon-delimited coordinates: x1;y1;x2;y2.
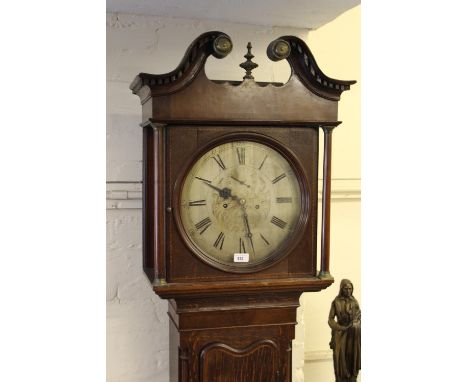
319;126;334;279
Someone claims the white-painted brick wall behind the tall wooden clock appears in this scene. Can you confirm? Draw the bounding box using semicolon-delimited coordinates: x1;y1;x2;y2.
107;14;312;382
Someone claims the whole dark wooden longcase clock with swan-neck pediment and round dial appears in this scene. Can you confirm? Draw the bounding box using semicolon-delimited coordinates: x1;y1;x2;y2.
130;32;354;382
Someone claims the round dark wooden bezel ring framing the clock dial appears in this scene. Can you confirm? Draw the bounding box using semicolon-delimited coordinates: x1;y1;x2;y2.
173;132;310;273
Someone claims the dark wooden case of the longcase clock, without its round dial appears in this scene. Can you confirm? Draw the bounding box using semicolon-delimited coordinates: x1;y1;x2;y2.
130;32;355;382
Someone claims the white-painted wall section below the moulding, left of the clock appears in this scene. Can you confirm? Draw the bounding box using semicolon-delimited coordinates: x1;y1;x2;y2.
107;208;169;382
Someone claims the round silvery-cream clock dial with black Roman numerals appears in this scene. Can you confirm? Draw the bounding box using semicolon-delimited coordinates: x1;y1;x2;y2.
179;140;303;269
